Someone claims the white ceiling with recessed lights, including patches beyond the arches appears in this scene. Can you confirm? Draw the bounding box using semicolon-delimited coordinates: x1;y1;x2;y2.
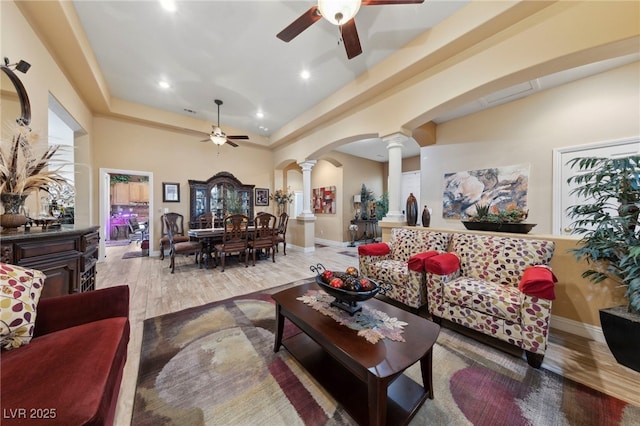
73;0;638;161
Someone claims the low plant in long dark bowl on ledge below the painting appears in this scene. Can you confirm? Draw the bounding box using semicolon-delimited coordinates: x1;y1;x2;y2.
462;204;536;234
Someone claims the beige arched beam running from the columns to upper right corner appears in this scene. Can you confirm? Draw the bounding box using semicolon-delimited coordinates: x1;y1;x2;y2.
274;1;640;164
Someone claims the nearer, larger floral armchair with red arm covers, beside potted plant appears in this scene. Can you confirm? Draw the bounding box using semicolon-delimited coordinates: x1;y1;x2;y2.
425;233;555;368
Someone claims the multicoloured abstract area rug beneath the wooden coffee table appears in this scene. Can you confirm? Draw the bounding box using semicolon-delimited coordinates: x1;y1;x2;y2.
131;281;640;426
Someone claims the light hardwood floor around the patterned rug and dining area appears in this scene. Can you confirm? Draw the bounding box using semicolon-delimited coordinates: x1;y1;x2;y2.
97;243;640;426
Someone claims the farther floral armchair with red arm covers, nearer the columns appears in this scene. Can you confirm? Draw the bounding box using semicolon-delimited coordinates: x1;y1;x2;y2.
358;228;451;309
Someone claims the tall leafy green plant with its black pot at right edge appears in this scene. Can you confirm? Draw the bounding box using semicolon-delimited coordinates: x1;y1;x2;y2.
567;155;640;371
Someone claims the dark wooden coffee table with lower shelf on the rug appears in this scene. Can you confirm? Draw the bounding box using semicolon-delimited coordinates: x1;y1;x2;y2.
273;281;440;425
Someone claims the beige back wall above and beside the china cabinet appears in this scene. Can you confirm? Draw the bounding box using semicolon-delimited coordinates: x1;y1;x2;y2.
93;117;275;247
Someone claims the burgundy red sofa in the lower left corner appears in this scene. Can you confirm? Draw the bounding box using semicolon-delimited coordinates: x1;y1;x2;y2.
0;286;129;425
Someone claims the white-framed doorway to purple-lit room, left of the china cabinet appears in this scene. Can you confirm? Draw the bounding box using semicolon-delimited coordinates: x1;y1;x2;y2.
98;168;154;261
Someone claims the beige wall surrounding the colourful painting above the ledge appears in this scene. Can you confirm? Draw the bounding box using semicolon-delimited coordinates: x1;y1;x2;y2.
420;62;640;234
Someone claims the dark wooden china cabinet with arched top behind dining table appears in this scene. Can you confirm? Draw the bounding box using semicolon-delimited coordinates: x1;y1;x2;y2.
189;172;255;229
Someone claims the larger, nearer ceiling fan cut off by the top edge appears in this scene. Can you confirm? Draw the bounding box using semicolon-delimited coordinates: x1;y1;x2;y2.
276;0;424;59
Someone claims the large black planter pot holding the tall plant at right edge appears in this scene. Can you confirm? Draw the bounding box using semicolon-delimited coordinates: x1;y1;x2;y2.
600;306;640;372
